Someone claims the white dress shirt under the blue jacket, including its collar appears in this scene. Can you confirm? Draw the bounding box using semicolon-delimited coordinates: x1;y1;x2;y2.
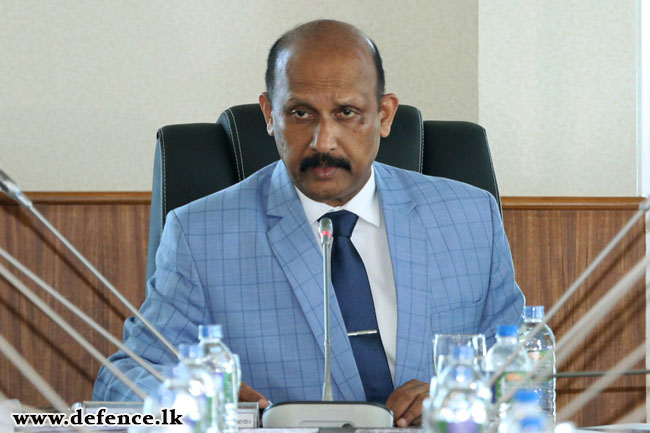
296;167;397;382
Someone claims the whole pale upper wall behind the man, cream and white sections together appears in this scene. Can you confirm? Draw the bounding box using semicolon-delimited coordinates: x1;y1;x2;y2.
0;0;637;196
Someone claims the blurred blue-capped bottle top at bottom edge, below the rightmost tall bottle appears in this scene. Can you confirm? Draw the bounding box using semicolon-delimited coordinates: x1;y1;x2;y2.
499;388;553;433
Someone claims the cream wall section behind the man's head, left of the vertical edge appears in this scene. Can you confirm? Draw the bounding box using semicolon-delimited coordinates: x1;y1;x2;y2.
0;0;478;191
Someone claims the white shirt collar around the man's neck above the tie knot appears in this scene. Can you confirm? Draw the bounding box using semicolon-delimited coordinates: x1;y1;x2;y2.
294;166;381;227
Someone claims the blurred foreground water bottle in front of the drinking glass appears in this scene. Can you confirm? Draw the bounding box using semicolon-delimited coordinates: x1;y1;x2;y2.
423;346;491;433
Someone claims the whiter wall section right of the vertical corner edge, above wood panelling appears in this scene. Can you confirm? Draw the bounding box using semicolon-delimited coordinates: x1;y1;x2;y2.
478;0;637;196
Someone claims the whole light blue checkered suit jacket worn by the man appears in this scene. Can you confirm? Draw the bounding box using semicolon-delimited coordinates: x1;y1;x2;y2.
93;162;524;402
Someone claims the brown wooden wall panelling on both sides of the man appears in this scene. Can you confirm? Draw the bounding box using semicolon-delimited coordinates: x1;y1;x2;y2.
0;193;645;426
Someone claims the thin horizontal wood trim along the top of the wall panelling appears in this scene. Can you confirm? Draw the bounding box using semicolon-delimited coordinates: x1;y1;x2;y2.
0;191;643;210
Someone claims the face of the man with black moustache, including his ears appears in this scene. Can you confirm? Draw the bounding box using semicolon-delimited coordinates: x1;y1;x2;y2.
260;43;397;206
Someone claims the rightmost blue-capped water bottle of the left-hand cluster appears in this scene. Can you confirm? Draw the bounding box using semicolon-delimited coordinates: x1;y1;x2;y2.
199;325;241;433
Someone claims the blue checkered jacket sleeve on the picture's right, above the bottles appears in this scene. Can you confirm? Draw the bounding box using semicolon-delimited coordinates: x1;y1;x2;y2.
479;192;525;348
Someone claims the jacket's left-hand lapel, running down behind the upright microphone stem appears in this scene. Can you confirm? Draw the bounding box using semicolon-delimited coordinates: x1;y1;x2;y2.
267;161;365;401
